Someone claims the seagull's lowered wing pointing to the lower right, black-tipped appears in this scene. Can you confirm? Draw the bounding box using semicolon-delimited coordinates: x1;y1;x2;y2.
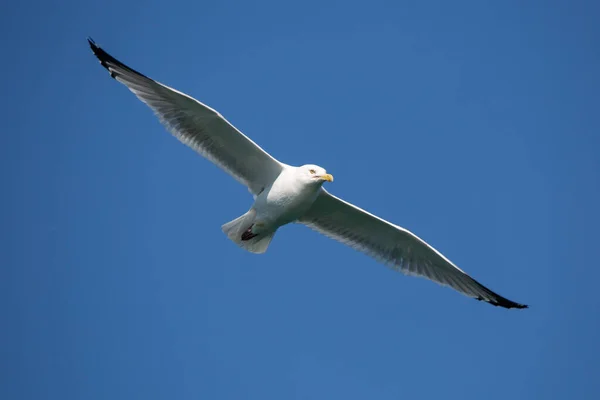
299;189;527;308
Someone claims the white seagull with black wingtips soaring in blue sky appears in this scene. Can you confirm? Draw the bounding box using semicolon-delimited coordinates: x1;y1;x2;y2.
88;38;528;308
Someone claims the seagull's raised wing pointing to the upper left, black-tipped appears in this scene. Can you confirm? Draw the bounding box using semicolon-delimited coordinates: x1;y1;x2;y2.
88;39;283;195
